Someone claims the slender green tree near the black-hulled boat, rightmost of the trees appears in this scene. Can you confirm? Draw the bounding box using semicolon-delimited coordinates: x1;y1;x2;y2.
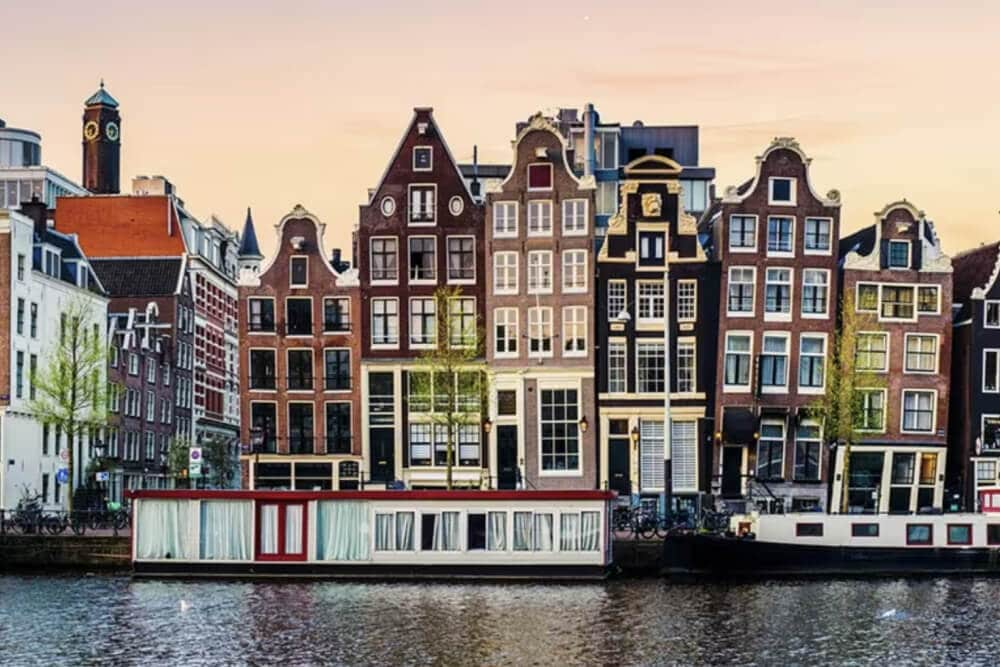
809;290;888;514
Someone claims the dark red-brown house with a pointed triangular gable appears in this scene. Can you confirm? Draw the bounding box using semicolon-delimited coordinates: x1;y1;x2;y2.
354;108;489;488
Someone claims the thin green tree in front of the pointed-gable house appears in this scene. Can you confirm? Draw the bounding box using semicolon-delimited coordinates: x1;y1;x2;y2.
409;287;490;490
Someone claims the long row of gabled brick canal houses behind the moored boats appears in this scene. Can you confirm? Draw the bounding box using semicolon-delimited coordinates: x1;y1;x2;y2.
239;105;1000;511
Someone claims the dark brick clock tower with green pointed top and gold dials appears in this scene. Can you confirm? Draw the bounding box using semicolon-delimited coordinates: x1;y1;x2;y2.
83;79;122;195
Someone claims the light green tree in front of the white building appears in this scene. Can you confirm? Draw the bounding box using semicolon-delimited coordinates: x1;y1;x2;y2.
28;297;108;511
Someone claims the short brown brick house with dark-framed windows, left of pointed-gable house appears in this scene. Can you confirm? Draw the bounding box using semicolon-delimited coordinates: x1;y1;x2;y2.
239;206;362;490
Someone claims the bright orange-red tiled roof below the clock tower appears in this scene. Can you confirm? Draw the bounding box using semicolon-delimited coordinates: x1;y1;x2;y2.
56;195;185;258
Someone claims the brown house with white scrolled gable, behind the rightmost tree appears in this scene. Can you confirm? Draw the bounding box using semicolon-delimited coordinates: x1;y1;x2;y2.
831;200;953;513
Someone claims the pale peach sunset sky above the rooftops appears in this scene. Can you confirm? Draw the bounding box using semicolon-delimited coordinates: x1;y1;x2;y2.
0;0;1000;254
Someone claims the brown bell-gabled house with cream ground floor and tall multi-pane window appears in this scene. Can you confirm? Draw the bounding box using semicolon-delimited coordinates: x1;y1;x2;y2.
486;114;599;489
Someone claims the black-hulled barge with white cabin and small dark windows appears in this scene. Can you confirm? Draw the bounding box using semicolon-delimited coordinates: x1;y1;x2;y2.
663;491;1000;577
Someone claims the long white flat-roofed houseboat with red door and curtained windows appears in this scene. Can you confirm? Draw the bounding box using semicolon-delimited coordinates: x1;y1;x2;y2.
130;490;615;580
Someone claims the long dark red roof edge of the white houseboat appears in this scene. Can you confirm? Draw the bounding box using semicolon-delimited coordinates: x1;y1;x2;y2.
125;489;618;501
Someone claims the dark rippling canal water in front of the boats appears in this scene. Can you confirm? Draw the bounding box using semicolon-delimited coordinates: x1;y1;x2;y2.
0;576;1000;667
